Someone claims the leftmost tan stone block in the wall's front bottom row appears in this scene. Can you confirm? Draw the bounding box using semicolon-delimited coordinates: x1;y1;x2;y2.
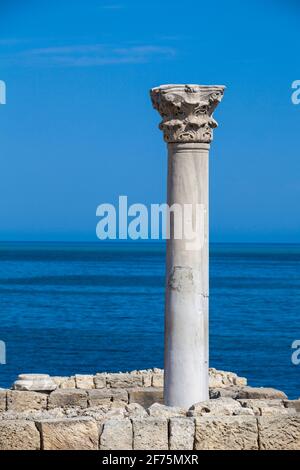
0;420;41;450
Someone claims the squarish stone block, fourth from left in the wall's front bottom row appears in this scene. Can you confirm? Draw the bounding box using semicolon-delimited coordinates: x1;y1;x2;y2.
132;418;168;450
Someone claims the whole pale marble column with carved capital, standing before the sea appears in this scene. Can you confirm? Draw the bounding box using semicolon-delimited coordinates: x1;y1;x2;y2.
150;85;225;408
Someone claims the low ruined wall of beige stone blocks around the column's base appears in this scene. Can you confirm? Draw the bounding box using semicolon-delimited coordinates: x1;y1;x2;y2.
0;369;300;450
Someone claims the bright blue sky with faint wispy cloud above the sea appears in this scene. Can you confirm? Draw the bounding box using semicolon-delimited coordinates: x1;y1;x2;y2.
0;0;300;242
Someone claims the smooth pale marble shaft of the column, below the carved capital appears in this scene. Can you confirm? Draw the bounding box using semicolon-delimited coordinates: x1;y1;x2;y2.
164;143;209;407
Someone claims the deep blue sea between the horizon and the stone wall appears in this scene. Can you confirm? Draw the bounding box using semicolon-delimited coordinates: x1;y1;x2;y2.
0;242;300;398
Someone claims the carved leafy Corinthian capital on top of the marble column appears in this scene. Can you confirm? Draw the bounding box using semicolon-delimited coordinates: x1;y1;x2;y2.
150;85;225;143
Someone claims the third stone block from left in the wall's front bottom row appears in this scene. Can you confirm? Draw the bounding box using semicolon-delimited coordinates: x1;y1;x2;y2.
100;418;133;450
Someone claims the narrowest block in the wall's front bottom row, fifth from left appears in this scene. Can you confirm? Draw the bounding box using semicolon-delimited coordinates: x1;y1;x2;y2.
169;417;195;450
